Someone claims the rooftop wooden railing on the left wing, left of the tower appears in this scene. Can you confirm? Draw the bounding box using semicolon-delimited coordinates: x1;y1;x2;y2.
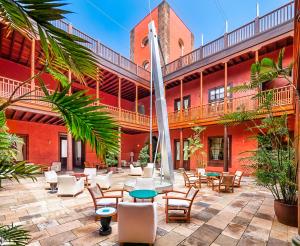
52;20;150;81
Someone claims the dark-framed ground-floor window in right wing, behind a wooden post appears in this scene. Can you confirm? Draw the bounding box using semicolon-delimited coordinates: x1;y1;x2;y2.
208;136;231;166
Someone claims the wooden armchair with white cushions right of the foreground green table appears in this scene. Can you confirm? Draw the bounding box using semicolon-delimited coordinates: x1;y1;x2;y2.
163;186;199;223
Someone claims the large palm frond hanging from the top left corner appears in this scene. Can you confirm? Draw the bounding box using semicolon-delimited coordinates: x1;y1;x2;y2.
0;0;97;82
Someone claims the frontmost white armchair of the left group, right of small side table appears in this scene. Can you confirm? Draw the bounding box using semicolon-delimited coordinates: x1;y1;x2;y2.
57;175;84;196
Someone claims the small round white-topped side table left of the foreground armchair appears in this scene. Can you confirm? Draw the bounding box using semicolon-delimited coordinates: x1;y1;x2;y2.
96;207;117;236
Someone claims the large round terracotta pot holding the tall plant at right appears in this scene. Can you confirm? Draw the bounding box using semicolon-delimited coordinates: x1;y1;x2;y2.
274;200;298;227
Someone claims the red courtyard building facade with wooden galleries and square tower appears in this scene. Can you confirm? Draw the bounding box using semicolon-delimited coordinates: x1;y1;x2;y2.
0;1;295;171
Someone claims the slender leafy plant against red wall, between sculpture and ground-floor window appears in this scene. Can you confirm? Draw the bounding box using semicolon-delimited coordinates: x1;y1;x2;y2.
183;126;206;167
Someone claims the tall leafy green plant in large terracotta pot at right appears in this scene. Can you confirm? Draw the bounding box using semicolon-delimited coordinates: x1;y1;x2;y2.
223;49;299;226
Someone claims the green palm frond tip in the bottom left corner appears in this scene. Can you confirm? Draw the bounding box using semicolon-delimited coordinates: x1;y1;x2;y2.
0;225;30;246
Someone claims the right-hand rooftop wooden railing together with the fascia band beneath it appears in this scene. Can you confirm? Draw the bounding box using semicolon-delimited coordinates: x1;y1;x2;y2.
163;1;294;81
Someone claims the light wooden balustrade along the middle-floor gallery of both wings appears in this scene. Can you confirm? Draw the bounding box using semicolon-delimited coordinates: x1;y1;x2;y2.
0;77;294;130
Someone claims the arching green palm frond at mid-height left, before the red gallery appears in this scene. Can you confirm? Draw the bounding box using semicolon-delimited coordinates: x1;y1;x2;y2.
42;86;118;157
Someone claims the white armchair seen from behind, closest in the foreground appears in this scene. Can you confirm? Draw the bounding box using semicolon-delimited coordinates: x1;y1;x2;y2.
118;202;157;244
